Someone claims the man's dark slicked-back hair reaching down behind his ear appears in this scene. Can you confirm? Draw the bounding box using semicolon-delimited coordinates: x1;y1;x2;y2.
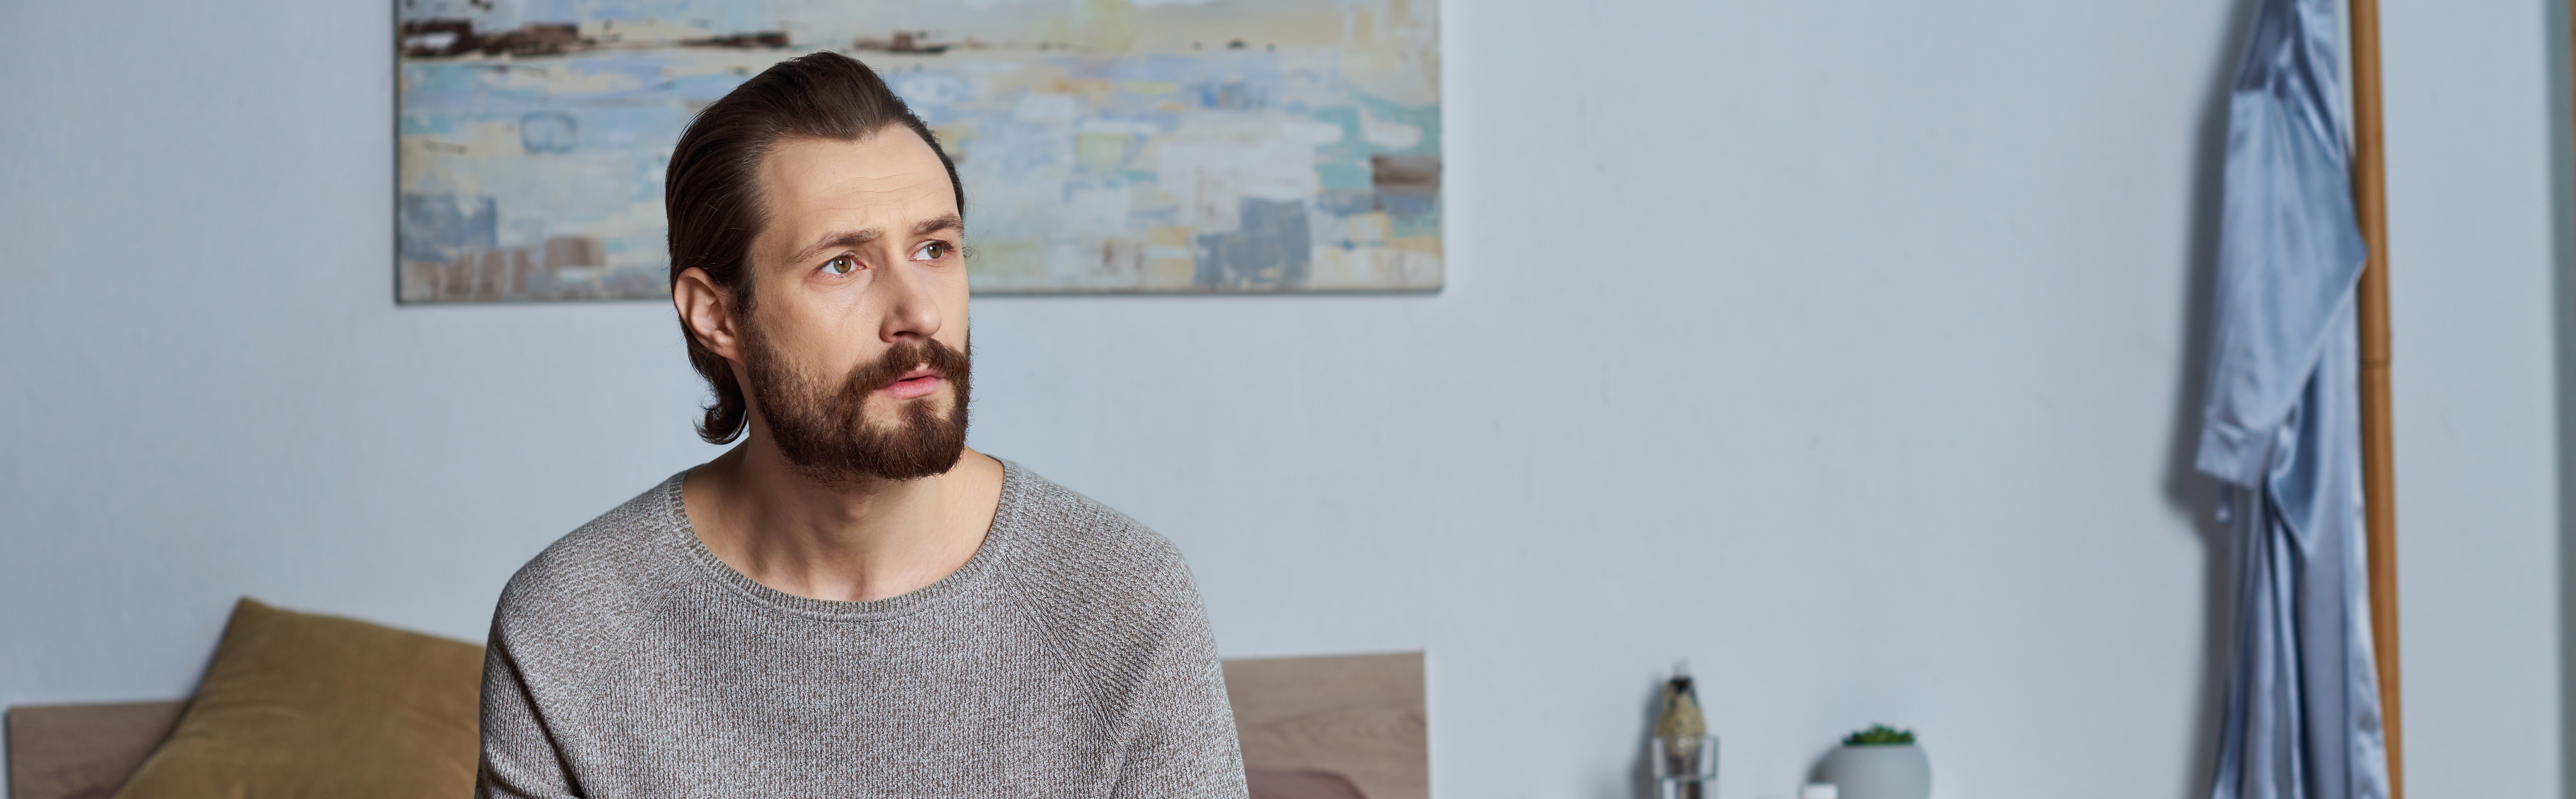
662;51;966;443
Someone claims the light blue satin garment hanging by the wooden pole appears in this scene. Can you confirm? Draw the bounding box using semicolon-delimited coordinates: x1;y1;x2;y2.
2197;0;2388;799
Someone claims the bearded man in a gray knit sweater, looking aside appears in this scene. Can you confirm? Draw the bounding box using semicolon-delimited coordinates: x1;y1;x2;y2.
477;54;1244;797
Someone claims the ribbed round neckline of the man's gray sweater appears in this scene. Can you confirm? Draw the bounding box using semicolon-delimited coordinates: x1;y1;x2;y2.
659;459;1028;621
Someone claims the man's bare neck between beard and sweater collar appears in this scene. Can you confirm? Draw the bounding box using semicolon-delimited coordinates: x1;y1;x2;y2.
680;440;1002;601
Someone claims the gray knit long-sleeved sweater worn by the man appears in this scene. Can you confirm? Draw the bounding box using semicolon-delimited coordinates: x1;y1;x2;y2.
477;461;1244;799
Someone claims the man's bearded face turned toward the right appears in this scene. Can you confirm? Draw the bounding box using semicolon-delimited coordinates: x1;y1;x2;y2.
739;126;968;482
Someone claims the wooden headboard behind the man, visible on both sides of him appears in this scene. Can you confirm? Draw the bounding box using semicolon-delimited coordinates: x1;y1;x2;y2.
8;652;1430;799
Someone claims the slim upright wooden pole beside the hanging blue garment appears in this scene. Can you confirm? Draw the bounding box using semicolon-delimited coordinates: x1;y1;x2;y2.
2349;0;2406;799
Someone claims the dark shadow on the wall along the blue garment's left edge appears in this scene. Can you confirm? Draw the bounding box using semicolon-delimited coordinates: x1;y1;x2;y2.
2164;0;2256;799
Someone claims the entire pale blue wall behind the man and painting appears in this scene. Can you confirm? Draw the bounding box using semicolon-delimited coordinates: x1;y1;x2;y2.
0;0;2566;799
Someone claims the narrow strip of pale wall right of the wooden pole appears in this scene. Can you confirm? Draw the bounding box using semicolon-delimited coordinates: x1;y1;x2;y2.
2385;2;2576;797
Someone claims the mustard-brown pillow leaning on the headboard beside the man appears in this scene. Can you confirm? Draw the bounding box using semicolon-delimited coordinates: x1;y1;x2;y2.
116;598;482;799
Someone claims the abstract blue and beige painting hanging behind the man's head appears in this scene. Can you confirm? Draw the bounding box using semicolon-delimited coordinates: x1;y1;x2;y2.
397;0;1443;302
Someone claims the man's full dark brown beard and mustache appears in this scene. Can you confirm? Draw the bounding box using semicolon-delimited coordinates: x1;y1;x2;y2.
742;327;974;487
